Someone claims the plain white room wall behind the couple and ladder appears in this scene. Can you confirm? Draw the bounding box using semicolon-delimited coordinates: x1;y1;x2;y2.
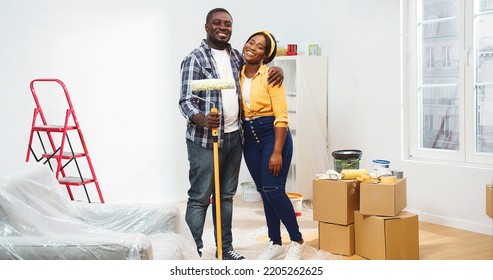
0;0;493;234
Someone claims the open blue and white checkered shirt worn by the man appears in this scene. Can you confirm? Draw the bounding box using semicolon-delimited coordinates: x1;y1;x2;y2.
179;40;243;149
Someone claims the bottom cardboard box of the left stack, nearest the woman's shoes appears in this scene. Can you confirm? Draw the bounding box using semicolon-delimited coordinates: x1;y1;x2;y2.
318;222;354;256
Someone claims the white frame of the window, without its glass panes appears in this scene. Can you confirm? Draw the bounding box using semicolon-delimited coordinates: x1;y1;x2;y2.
401;0;493;166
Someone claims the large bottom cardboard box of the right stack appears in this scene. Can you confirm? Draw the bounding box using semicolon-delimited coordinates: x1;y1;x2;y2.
354;211;419;260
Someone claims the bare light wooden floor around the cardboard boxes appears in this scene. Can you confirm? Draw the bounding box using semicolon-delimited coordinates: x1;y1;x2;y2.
343;222;493;260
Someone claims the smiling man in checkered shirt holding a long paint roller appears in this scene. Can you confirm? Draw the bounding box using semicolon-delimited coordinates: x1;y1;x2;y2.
179;8;283;260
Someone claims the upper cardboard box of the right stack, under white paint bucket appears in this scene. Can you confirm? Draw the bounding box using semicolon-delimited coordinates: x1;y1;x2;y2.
359;178;407;217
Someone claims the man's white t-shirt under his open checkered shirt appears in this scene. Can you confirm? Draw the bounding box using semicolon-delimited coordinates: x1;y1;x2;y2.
211;49;240;133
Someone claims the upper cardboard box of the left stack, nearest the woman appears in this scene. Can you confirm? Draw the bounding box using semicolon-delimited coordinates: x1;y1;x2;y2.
312;179;359;225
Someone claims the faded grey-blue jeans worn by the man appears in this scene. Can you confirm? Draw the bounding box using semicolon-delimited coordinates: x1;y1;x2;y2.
185;131;242;255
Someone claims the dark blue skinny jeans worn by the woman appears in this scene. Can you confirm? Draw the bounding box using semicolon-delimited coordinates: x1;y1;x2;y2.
243;117;302;245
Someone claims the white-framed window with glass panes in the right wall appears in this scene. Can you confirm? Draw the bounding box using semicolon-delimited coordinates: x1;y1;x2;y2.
401;0;493;164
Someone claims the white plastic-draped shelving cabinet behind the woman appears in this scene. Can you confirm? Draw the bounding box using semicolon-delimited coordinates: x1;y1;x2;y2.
270;55;331;200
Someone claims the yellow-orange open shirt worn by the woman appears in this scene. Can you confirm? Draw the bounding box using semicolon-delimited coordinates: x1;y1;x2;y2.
240;65;288;127
